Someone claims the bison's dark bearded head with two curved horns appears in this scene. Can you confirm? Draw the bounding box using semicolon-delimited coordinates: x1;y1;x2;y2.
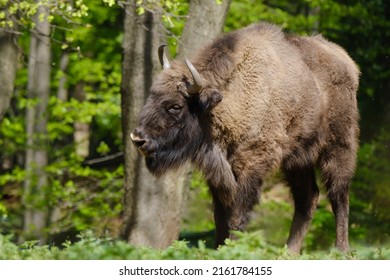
130;45;222;176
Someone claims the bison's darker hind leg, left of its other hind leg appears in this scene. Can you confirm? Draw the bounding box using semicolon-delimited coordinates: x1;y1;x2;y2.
284;167;319;253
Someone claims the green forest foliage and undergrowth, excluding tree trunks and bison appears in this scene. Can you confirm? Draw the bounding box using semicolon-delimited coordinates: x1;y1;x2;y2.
0;0;390;259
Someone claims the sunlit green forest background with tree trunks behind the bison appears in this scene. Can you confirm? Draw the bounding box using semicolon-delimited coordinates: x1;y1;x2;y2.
0;0;390;252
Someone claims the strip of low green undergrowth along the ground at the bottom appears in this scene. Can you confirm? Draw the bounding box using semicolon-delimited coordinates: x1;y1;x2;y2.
0;233;390;260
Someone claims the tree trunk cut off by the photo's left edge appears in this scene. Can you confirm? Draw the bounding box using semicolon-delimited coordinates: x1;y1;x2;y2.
0;29;18;122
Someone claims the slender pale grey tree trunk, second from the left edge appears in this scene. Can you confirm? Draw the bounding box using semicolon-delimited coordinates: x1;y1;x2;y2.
22;3;51;243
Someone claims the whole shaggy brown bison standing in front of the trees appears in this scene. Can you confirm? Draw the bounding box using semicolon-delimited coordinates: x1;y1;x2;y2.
130;23;359;252
